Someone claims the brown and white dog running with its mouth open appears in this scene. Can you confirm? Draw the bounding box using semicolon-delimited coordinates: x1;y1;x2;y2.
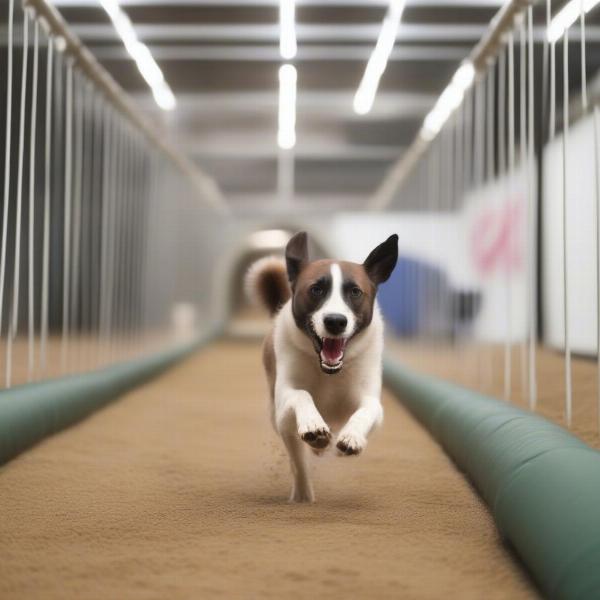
246;232;398;502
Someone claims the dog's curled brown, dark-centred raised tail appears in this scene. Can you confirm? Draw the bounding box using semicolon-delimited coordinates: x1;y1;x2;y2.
245;256;291;315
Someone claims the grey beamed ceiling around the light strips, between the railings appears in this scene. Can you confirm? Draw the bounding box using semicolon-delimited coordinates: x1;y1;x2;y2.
54;0;596;210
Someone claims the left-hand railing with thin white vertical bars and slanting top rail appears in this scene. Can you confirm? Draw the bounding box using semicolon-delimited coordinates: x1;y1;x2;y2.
0;0;227;386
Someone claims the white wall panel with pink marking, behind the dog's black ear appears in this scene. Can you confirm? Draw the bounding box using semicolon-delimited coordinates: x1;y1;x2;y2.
331;176;528;342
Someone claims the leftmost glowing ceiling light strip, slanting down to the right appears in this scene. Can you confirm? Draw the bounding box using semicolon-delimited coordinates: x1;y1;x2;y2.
100;0;176;110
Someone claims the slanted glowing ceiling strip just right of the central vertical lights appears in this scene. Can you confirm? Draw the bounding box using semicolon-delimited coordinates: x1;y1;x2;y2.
354;0;406;115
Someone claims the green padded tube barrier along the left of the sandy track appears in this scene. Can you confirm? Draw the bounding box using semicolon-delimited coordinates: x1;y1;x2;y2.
0;331;216;464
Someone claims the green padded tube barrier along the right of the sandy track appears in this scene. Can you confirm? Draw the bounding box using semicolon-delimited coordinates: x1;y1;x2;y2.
384;357;600;600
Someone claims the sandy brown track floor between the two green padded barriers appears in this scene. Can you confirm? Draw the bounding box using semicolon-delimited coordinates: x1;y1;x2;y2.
0;342;537;600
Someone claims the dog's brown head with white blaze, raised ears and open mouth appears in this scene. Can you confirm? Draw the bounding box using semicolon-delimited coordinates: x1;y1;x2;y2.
285;232;398;374
